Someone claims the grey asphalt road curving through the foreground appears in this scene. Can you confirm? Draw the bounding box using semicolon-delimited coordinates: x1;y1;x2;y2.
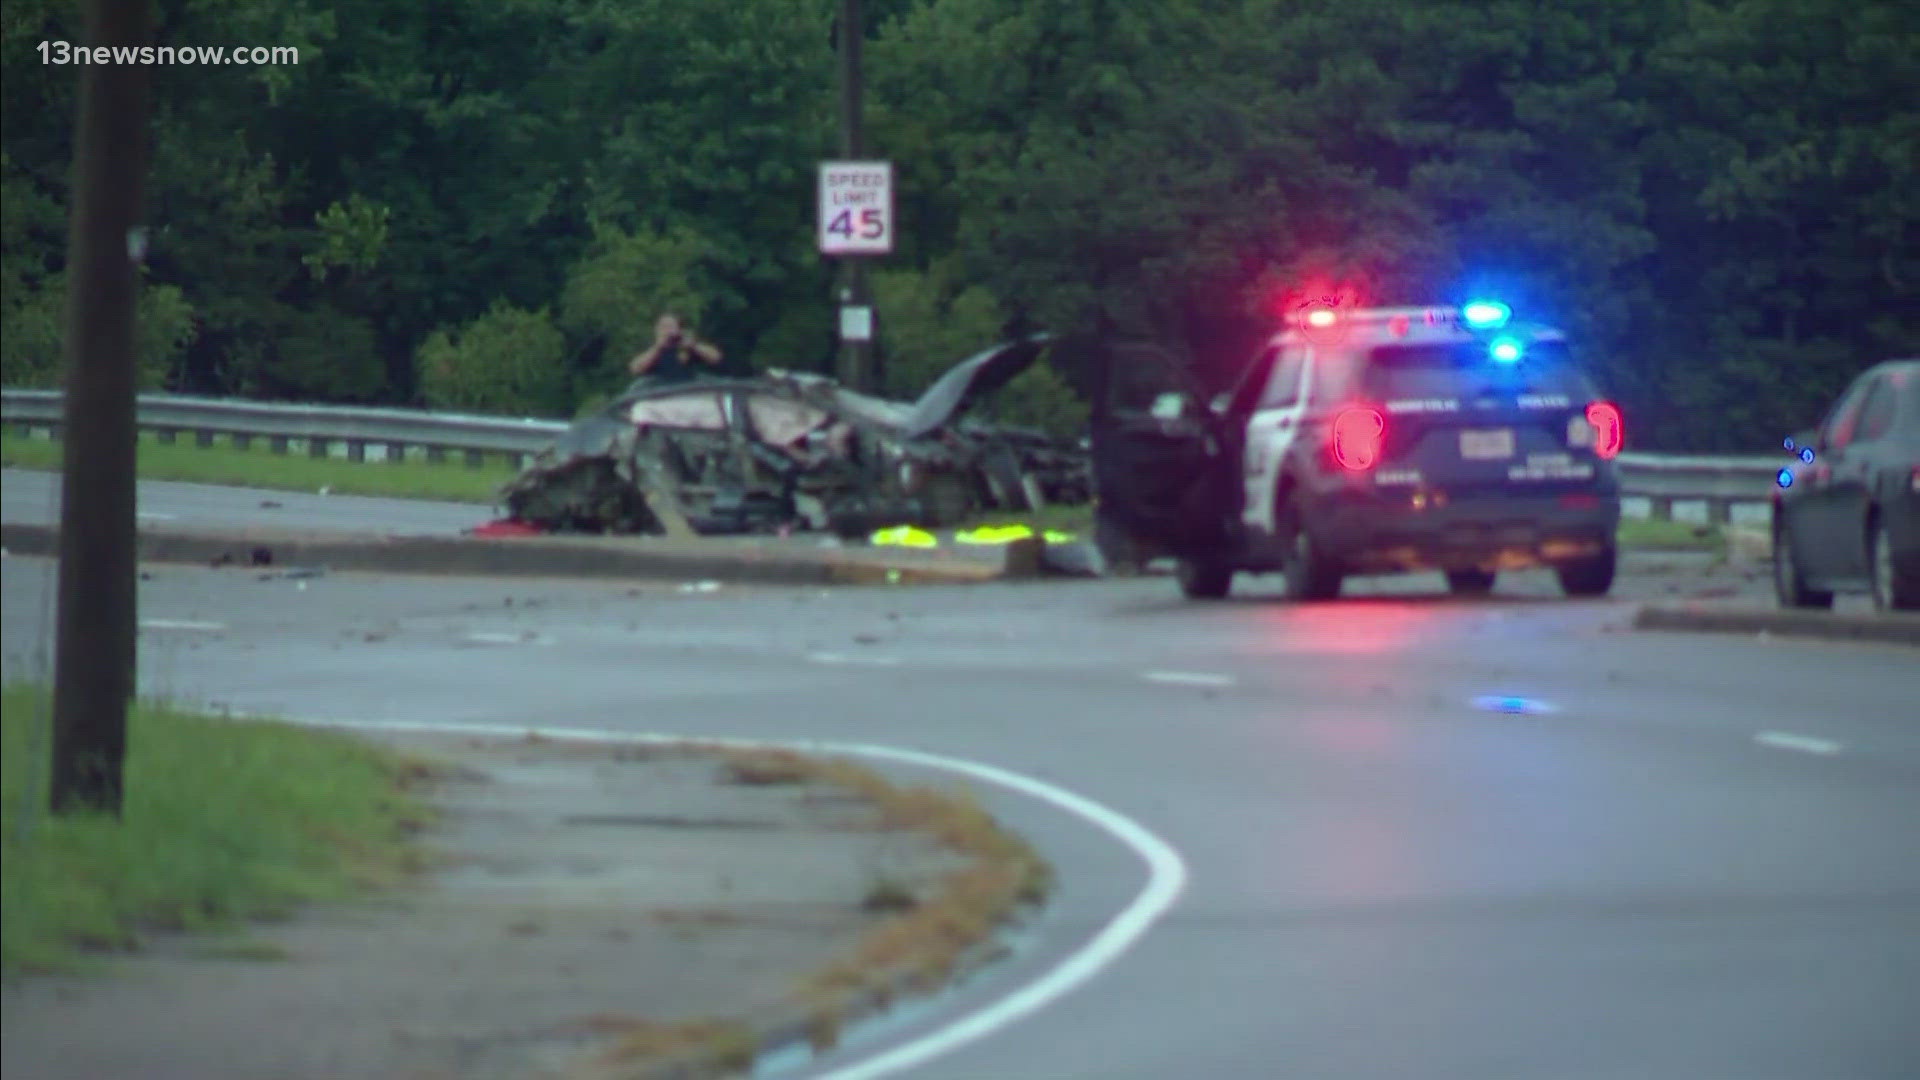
0;490;1920;1080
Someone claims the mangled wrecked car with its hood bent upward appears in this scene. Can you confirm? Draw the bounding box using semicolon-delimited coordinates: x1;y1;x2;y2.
501;336;1091;536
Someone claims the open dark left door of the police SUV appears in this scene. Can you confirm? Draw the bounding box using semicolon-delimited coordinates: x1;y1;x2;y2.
1091;348;1233;565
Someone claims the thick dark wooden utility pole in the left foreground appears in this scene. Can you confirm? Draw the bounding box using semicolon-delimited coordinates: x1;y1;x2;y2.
52;0;150;815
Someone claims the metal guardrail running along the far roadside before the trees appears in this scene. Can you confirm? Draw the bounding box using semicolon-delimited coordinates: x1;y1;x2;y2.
0;390;1780;523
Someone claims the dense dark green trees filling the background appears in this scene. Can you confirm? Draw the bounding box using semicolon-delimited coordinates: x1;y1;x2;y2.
0;0;1920;450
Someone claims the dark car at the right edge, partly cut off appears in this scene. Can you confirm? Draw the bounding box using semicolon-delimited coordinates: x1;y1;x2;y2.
1774;359;1920;611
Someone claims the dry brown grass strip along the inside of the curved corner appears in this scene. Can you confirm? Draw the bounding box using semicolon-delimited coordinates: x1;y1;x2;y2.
595;748;1052;1068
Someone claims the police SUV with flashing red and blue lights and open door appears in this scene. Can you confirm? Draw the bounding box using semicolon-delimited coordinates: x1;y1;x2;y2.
1094;302;1622;600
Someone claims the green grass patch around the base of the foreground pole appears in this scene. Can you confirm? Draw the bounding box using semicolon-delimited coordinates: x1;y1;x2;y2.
0;682;428;972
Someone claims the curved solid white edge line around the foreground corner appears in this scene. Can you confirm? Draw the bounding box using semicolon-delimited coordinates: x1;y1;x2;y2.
294;719;1187;1080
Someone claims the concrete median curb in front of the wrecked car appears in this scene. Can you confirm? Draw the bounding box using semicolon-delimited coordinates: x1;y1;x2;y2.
0;523;1043;584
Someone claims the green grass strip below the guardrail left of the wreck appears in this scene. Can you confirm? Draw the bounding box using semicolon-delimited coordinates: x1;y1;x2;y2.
0;430;518;503
